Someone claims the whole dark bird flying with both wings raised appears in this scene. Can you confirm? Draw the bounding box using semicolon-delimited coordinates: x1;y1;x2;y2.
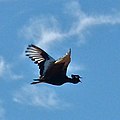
25;44;82;86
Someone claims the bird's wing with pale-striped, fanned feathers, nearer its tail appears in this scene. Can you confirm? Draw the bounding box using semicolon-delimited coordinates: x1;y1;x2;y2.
25;44;55;76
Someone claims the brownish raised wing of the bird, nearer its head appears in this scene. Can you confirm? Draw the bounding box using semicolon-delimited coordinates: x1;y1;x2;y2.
55;49;71;74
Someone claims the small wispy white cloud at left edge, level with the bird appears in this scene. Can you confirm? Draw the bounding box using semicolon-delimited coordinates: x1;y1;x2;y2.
0;56;23;80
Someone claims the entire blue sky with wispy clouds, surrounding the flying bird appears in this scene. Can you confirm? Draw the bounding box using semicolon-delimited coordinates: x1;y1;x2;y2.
0;0;120;120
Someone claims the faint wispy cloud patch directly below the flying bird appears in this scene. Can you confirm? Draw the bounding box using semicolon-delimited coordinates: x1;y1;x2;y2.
13;85;68;109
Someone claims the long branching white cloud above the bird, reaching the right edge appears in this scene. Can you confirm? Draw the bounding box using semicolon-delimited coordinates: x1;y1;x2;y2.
21;1;120;47
